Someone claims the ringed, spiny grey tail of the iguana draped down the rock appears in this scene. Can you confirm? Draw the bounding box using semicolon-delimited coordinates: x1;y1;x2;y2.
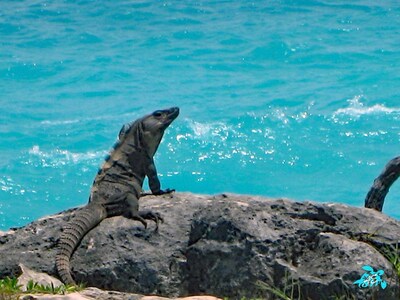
56;204;106;285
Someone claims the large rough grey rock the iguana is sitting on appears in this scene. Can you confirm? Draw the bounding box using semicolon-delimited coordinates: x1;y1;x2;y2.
0;193;400;299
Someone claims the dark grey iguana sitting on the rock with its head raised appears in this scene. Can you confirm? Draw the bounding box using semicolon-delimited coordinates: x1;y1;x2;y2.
56;107;179;285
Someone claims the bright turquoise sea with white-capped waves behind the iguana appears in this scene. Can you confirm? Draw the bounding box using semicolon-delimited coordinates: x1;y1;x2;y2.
0;0;400;230
